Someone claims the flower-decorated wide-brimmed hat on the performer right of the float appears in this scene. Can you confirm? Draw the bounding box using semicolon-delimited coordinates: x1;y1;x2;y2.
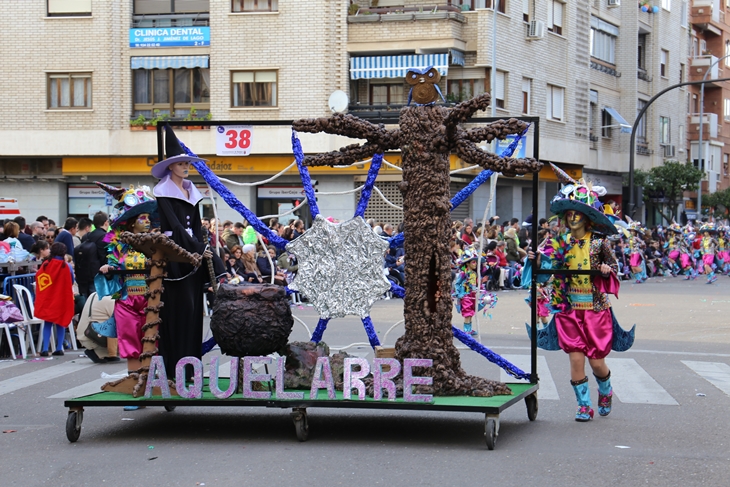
550;163;618;235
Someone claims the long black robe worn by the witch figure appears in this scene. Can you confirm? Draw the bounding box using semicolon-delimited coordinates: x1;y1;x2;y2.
157;183;225;375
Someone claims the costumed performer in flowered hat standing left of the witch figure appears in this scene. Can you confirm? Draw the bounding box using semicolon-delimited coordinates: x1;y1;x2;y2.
92;182;157;382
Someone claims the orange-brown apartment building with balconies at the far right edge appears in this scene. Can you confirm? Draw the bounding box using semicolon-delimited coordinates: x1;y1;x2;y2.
684;0;730;221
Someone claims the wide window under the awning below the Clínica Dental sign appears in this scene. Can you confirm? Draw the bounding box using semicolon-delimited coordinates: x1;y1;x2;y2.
133;68;210;118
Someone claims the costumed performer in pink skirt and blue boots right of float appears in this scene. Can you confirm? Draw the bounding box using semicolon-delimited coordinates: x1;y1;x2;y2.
528;168;633;422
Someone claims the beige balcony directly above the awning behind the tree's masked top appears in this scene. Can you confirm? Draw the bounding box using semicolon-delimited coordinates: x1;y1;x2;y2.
347;5;466;53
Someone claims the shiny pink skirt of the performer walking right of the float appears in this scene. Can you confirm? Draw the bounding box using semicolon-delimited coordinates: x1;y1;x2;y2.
555;309;613;359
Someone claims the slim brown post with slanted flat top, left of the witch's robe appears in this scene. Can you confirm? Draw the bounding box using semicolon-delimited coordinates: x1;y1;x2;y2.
101;232;201;397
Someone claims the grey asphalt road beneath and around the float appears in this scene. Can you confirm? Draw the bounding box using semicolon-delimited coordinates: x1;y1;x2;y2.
0;276;730;486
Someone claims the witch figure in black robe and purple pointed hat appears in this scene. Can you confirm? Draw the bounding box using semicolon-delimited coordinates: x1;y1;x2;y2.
152;125;226;377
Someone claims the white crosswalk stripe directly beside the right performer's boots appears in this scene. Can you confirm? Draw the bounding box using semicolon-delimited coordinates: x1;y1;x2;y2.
606;358;679;406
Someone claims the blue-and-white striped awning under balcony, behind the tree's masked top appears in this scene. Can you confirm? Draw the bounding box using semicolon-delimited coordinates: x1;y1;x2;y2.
350;52;449;79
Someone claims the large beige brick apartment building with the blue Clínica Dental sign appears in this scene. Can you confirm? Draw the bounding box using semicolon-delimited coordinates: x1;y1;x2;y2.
0;0;689;228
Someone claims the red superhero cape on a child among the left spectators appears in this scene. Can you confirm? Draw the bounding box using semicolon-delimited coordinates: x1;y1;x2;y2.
35;259;74;327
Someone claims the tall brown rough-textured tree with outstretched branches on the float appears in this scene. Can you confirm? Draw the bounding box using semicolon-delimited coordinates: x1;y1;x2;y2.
293;94;542;396
